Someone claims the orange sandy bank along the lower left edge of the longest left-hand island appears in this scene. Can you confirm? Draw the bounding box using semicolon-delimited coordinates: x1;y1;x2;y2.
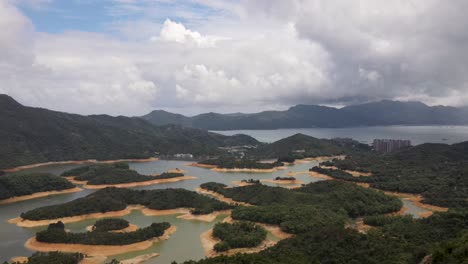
8;205;144;228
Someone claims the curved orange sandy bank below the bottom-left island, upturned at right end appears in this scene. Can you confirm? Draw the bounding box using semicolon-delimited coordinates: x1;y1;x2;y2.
24;226;177;256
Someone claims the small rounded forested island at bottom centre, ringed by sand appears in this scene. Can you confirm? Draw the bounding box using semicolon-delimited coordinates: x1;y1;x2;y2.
213;222;267;252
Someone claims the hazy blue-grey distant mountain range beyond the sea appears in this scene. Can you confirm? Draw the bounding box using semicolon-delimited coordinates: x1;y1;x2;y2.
142;100;468;130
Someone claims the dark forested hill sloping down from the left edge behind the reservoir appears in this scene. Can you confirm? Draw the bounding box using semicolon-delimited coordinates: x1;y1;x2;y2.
0;95;258;169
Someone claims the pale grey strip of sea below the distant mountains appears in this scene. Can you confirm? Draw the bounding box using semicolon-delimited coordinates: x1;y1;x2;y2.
213;126;468;145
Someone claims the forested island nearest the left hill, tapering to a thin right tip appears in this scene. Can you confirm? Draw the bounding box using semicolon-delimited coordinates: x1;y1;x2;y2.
61;163;188;185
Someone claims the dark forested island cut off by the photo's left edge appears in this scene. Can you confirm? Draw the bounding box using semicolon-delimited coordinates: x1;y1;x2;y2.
0;173;75;202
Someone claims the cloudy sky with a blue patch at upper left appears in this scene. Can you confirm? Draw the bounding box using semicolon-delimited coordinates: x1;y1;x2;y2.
0;0;468;116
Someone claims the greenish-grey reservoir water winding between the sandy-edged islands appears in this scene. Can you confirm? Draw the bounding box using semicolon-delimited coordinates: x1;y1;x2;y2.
0;161;428;264
